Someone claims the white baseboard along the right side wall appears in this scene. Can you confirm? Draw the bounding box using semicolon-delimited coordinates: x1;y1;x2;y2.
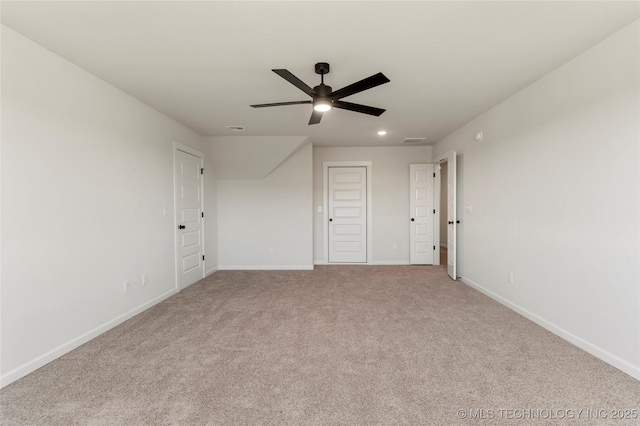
460;277;640;380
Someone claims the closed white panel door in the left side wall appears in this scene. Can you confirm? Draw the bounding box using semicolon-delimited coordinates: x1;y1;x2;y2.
175;150;204;288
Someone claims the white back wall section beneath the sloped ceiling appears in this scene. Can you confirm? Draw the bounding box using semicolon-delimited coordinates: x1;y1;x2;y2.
217;143;313;269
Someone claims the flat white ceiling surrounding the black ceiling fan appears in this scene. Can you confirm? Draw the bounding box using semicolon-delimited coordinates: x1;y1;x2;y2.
1;1;639;146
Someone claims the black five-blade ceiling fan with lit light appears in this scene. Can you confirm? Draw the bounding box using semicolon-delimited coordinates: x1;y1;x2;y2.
250;62;391;124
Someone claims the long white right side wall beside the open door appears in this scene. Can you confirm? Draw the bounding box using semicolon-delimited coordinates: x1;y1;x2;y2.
434;21;640;378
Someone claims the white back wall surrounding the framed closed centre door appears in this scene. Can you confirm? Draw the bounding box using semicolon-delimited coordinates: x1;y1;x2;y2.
313;146;431;264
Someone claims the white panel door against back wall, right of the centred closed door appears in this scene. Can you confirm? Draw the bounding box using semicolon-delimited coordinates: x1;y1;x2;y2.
409;164;435;265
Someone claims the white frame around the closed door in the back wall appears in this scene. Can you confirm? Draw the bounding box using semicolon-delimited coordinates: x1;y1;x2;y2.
322;161;373;265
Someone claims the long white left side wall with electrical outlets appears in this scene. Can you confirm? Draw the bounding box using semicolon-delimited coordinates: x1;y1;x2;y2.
0;26;215;385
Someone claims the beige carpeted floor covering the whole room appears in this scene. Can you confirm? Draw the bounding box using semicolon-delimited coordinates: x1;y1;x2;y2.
0;266;640;425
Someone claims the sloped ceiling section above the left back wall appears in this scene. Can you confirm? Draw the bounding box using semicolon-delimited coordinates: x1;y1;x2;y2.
205;136;310;180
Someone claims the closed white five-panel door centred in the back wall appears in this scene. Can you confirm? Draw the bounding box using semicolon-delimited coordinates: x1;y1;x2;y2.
328;167;367;263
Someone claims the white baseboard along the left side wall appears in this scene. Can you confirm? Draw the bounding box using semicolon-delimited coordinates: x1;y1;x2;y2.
0;289;177;388
